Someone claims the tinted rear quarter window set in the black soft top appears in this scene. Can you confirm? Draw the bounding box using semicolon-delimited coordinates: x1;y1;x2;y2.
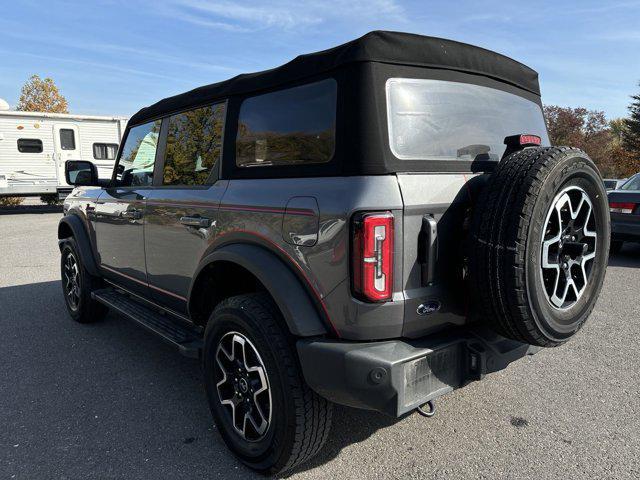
236;79;337;167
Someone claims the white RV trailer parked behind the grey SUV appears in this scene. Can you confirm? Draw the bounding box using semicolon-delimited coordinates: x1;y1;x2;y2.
0;110;127;196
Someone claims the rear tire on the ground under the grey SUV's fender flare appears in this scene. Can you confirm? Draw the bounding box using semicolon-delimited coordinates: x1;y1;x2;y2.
203;294;333;474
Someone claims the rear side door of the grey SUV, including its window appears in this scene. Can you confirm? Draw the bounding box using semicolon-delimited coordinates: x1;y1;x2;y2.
145;103;228;313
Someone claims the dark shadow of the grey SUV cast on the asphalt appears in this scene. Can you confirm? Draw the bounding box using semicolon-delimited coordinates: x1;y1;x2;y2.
0;281;395;479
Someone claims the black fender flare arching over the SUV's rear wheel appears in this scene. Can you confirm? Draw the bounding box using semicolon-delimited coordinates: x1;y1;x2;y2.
189;243;327;337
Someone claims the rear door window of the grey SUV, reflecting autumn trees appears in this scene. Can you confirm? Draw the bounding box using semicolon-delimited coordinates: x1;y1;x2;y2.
162;103;225;185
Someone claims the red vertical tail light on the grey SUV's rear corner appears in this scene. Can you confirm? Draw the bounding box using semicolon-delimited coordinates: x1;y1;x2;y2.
353;212;393;302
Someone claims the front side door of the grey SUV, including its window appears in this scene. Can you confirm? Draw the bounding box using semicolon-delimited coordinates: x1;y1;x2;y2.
95;120;161;295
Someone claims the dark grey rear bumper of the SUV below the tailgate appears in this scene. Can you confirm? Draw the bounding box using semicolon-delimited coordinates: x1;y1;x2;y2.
297;329;540;417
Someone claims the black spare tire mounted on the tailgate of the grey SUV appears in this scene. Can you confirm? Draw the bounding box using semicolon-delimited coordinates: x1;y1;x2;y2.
469;147;610;347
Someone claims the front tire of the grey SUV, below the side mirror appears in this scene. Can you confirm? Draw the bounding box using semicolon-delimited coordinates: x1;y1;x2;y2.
60;237;109;323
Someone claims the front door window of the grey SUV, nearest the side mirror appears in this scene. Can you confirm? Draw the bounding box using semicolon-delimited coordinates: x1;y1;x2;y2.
116;120;162;187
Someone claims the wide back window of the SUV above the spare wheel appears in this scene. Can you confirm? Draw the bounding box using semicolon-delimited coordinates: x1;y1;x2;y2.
386;78;549;160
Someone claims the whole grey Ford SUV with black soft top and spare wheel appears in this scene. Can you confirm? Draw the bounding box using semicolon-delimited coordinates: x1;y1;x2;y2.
58;32;610;473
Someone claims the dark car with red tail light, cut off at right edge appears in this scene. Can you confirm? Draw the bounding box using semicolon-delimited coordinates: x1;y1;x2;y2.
607;173;640;253
